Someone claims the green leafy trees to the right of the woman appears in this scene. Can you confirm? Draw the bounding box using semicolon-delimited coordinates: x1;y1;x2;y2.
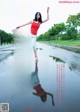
37;13;80;41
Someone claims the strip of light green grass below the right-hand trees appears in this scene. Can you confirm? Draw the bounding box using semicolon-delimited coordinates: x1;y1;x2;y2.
42;40;80;47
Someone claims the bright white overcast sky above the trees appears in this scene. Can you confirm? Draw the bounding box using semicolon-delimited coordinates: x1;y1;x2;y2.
0;0;80;35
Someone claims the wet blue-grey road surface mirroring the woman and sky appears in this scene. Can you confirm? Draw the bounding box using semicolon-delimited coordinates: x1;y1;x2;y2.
0;43;80;112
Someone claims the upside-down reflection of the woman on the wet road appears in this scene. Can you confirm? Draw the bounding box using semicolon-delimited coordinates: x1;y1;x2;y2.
31;61;54;106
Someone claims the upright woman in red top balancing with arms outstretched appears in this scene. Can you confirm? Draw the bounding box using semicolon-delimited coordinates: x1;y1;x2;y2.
16;7;49;61
